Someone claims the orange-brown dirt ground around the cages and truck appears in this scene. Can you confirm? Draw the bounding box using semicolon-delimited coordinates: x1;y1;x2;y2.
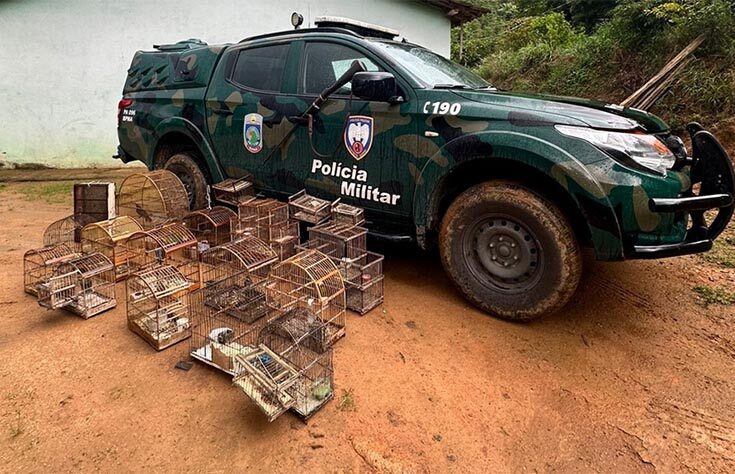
0;176;735;473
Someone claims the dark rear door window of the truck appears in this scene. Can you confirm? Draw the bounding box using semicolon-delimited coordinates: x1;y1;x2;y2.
232;44;291;92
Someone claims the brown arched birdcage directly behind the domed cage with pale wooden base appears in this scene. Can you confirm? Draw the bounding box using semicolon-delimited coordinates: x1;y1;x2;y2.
125;224;201;289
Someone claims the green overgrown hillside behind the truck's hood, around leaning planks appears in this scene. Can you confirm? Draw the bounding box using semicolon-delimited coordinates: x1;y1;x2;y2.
452;0;735;128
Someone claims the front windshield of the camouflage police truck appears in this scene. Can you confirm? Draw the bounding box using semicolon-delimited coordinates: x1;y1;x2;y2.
373;41;491;89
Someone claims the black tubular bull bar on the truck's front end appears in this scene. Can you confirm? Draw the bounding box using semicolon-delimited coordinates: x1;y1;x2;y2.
630;123;735;259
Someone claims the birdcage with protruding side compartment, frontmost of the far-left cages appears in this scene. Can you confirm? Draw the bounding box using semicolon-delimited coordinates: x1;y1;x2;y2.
38;253;117;319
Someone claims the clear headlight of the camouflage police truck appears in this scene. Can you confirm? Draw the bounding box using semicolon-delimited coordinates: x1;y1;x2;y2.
556;125;676;176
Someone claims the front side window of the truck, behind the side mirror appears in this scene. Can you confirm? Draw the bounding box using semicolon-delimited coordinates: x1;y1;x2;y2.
303;43;381;94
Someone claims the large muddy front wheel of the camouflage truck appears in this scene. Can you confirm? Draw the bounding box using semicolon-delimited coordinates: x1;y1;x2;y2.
439;181;582;321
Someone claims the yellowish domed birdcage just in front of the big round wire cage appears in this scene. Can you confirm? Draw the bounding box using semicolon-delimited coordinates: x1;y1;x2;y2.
82;216;143;281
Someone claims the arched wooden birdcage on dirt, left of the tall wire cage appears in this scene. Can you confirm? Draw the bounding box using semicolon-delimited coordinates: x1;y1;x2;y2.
126;265;191;351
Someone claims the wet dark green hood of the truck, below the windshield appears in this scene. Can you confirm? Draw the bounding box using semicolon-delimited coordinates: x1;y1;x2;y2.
453;90;669;133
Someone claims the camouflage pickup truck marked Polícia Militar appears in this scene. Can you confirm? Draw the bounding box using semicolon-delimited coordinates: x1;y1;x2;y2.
117;20;735;320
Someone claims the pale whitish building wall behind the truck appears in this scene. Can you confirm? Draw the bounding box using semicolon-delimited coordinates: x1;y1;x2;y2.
0;0;450;166
